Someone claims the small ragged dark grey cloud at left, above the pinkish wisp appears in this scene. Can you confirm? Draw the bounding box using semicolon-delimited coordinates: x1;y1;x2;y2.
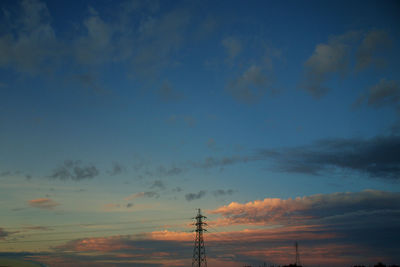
49;160;99;181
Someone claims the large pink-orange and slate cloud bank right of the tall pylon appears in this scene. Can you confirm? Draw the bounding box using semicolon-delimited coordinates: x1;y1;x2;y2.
208;190;400;265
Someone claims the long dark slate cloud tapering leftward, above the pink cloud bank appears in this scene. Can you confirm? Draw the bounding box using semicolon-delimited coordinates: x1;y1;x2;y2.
129;135;400;181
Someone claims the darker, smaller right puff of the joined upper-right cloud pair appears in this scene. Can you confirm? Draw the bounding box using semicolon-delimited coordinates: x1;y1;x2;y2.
356;30;392;70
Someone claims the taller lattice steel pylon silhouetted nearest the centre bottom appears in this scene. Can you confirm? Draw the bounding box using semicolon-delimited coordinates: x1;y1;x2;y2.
192;209;207;267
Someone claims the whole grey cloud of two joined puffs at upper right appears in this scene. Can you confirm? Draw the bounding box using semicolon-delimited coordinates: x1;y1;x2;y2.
301;29;391;98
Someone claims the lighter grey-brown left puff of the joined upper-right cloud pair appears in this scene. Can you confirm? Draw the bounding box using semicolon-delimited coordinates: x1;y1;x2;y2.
302;32;360;98
